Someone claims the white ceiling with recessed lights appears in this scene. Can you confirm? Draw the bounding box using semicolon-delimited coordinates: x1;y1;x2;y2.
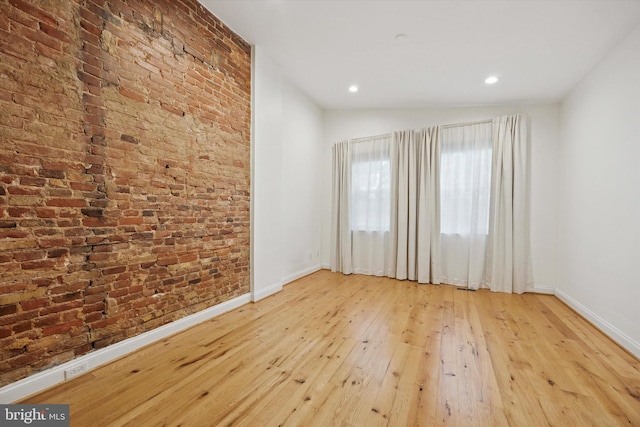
200;0;640;109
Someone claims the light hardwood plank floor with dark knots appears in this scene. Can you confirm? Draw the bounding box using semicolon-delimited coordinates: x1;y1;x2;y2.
25;271;640;427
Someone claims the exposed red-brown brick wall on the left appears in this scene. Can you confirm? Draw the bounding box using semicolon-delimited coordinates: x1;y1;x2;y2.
0;0;251;385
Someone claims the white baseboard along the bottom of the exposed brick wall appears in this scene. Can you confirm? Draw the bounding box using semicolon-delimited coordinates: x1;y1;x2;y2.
0;294;251;404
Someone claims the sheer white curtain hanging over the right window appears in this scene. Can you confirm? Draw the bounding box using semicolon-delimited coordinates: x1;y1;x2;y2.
440;122;492;289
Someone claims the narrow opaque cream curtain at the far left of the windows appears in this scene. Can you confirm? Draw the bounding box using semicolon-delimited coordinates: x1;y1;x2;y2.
330;141;353;274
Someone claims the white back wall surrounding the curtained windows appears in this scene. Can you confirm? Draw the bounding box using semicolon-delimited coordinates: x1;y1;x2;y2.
322;104;560;292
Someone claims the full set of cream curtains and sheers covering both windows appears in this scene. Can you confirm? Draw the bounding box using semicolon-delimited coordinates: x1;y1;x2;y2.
330;115;533;293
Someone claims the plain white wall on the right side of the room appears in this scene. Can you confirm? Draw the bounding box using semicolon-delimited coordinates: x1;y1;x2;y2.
557;27;640;357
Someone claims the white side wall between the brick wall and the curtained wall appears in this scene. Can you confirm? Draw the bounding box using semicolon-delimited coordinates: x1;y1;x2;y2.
251;46;323;301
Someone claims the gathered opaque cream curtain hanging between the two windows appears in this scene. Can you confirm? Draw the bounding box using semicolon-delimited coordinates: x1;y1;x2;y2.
387;127;440;283
